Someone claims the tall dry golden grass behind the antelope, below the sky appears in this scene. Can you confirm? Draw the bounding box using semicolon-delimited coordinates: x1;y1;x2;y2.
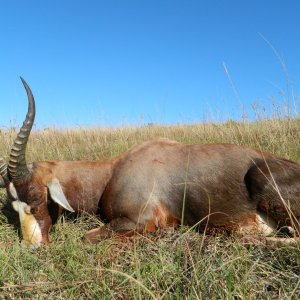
0;119;300;161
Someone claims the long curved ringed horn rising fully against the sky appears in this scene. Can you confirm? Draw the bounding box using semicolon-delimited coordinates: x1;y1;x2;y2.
8;77;35;182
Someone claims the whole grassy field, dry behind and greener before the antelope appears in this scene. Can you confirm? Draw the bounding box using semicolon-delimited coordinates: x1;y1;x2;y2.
0;119;300;299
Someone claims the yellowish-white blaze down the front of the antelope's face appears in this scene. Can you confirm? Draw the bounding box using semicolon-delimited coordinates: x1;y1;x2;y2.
12;200;43;249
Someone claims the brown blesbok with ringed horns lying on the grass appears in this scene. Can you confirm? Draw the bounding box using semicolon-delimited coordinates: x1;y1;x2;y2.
0;78;300;248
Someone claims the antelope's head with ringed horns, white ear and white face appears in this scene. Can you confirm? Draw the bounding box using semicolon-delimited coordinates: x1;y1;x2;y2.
0;78;74;249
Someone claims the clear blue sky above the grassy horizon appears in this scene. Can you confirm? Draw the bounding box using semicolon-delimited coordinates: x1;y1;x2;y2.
0;0;300;128
